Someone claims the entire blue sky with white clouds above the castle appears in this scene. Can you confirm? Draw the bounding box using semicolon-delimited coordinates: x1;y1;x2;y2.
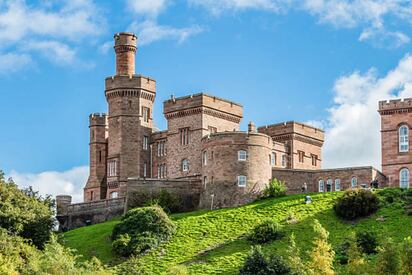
0;0;412;201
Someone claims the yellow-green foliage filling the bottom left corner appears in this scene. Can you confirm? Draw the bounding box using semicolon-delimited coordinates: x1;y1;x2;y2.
0;229;112;275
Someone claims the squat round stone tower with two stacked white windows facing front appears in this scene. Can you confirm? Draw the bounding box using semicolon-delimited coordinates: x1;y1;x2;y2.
200;131;273;208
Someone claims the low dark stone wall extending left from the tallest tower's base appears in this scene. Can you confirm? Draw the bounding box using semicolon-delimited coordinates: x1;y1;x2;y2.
57;198;126;231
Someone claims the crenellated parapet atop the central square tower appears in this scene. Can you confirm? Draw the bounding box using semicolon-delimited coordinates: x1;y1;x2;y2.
163;93;243;119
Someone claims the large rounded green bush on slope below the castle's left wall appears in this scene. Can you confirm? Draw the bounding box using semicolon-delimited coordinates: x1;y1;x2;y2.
112;206;175;256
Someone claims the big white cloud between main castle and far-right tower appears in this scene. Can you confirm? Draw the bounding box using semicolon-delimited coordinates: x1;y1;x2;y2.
323;55;412;168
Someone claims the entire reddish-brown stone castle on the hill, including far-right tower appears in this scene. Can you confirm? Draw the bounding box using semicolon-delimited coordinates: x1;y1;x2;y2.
57;33;412;231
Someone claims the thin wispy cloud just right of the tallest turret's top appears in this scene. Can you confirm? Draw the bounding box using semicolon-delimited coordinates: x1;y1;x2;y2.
130;20;203;45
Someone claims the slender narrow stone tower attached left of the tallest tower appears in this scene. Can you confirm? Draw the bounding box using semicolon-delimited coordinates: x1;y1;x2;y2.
84;114;107;202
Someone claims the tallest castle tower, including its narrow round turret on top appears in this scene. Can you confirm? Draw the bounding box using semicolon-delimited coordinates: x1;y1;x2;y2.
105;33;156;198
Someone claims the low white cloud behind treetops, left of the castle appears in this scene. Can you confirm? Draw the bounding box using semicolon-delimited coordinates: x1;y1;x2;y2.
6;166;89;202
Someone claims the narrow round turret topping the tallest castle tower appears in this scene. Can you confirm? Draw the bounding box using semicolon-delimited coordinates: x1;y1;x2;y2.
114;32;137;76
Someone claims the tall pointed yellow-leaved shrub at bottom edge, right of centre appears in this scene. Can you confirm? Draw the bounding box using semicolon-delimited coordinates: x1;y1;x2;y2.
309;220;335;275
